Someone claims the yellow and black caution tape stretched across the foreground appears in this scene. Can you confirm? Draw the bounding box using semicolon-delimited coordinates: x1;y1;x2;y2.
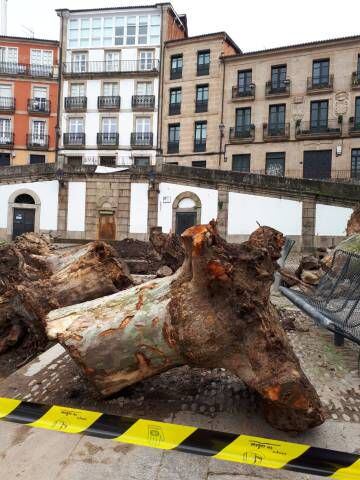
0;398;360;480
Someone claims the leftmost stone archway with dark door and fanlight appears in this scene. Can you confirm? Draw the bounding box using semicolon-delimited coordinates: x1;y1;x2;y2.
7;188;41;238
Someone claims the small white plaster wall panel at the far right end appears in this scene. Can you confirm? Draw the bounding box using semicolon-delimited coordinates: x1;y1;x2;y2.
315;203;352;236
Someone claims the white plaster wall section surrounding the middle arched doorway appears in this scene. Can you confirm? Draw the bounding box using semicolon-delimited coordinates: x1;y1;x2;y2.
158;183;218;233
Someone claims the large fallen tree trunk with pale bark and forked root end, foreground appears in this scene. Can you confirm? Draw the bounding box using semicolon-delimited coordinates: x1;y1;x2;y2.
47;223;324;432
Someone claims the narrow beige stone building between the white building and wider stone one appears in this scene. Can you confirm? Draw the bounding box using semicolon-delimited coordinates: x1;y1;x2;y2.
159;32;241;168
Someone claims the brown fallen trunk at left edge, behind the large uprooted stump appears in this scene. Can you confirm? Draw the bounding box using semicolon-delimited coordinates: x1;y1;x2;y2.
0;233;133;353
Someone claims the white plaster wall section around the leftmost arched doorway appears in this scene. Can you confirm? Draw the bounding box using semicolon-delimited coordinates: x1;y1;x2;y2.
0;180;59;230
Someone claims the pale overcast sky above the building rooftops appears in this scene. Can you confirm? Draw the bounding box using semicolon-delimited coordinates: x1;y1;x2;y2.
4;0;360;51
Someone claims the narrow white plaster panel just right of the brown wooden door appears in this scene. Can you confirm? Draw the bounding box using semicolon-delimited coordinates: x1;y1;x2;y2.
130;183;149;233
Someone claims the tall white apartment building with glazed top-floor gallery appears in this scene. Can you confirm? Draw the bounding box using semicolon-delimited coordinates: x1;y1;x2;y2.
57;3;187;166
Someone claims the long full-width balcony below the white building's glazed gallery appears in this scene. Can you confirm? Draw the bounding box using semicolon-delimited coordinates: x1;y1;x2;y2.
62;59;159;78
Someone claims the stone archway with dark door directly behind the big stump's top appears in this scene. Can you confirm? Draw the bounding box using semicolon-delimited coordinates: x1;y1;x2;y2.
172;192;201;235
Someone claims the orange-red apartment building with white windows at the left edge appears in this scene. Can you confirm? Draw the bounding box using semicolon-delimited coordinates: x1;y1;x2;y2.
0;36;59;166
